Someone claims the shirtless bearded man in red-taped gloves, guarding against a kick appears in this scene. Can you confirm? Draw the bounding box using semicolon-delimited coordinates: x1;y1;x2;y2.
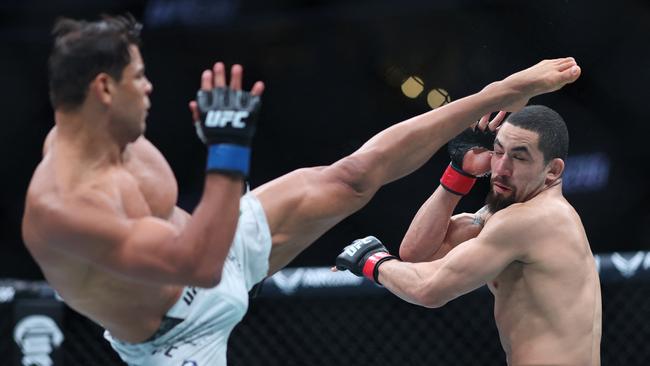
336;106;602;365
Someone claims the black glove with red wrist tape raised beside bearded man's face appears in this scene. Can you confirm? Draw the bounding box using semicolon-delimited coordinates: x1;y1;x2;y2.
440;127;496;196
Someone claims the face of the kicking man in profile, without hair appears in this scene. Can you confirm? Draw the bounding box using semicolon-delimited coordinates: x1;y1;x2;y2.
112;45;153;140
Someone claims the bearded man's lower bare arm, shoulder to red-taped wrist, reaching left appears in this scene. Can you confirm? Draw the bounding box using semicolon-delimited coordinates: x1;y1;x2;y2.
379;213;530;307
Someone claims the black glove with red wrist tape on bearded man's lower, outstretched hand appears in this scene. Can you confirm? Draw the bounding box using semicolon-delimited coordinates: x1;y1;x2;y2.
336;236;397;283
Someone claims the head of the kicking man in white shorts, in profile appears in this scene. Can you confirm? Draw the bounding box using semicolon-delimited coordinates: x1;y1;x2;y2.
49;14;152;142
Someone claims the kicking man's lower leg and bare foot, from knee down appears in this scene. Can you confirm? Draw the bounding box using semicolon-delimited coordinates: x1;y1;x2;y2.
344;58;580;190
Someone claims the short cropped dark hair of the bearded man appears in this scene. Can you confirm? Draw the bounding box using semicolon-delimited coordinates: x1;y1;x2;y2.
506;105;569;163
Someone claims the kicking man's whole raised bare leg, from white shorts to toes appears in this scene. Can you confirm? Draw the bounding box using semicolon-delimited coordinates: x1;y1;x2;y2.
253;58;580;274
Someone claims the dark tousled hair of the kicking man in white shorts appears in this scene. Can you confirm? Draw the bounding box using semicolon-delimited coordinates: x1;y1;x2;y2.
49;14;142;109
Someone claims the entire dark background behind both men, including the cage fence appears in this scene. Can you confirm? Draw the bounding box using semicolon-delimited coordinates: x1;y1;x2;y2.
0;0;650;366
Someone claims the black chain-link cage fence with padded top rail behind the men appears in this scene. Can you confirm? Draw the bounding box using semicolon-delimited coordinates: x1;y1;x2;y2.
0;252;650;366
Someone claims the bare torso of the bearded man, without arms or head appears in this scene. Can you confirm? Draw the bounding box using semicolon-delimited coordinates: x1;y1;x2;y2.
489;187;601;365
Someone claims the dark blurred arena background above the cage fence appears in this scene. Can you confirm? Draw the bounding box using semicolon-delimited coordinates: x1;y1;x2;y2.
0;0;650;279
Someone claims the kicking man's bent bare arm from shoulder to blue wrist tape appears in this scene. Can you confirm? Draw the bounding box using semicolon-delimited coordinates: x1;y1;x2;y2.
23;174;242;287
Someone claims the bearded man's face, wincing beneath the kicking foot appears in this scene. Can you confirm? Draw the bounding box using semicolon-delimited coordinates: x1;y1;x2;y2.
486;122;548;212
